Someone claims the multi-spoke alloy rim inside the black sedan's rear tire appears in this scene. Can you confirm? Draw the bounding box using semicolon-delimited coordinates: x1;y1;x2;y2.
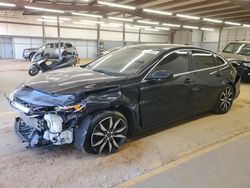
220;87;233;111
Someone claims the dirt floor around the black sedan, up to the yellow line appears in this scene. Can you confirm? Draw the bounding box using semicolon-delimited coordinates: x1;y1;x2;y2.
0;61;250;188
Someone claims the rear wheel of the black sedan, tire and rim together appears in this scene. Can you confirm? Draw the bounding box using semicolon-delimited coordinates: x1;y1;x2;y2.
214;84;235;114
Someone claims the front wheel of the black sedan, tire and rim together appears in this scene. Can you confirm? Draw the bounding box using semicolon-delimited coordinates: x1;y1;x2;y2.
84;111;128;154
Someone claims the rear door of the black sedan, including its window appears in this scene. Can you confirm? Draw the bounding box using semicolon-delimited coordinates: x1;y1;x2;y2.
192;50;224;114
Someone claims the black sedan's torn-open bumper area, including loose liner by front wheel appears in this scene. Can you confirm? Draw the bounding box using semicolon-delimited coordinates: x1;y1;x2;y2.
11;104;91;149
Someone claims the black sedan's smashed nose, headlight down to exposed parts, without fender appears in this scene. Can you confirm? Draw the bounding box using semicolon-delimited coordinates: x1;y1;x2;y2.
9;87;85;148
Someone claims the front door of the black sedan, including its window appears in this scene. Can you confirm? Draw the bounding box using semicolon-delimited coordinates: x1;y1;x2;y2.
140;50;194;128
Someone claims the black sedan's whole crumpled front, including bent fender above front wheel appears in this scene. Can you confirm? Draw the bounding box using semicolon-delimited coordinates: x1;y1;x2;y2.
8;86;125;149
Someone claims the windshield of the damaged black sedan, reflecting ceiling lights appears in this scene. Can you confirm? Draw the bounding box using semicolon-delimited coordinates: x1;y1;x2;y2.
86;48;160;75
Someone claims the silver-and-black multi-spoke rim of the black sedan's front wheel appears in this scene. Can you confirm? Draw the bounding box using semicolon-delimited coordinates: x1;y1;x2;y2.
91;116;127;154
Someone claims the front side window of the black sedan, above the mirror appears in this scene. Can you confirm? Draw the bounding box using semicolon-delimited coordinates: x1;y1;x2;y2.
154;50;189;74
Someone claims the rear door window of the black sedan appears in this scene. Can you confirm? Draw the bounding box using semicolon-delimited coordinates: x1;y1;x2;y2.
192;50;216;70
